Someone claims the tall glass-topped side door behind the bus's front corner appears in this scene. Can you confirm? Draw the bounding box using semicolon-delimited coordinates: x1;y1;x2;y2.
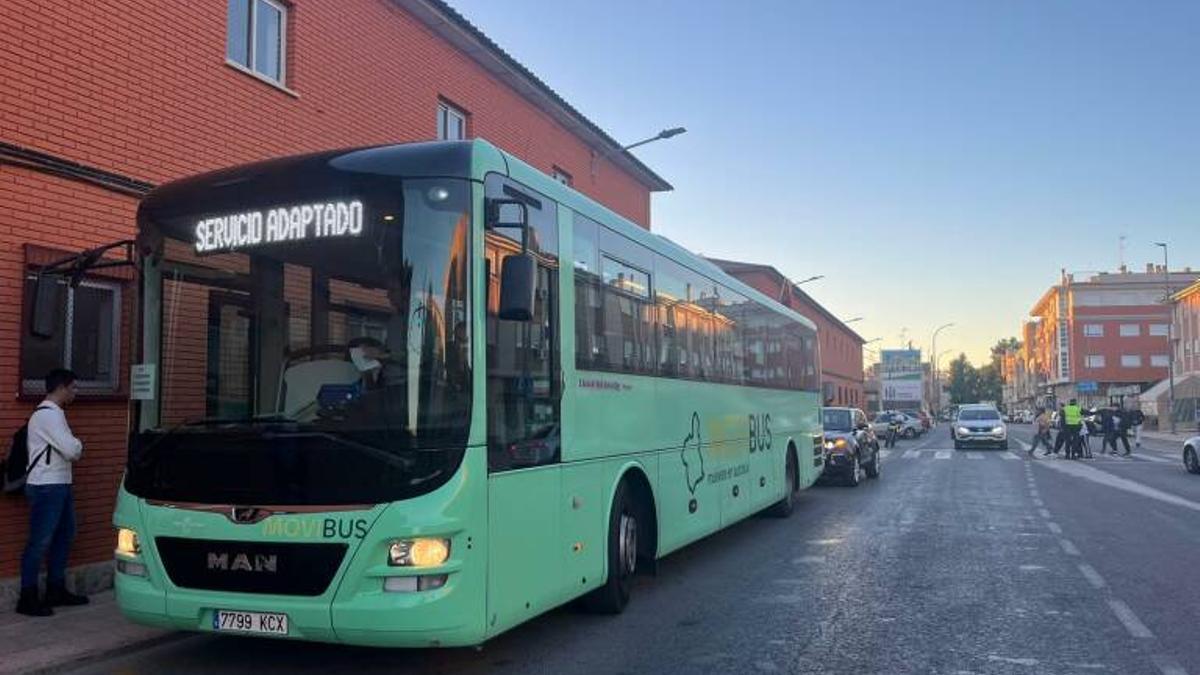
485;174;563;631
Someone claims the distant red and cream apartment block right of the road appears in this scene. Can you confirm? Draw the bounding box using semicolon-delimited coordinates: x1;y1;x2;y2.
1014;264;1200;405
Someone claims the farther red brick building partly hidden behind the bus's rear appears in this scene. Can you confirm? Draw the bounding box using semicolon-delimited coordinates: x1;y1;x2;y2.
709;258;866;410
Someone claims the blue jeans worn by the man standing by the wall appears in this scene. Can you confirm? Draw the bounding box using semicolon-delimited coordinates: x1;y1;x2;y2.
20;483;74;589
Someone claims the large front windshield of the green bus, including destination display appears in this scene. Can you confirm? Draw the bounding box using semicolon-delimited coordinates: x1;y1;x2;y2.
126;179;472;504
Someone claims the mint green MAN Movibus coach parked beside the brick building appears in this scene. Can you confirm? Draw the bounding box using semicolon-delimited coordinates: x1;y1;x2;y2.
100;141;823;646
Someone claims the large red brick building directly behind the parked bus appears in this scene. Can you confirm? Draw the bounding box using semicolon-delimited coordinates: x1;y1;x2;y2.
0;0;671;579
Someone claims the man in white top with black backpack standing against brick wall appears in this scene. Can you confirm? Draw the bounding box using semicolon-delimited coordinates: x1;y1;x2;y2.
17;369;88;616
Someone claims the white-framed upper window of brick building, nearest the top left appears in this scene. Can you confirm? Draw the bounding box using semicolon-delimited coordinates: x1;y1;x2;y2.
226;0;287;84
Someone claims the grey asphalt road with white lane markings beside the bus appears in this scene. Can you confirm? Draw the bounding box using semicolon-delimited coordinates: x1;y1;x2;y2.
63;426;1200;675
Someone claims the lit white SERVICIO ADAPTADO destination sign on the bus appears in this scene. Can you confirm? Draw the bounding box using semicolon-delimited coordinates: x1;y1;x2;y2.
196;199;362;253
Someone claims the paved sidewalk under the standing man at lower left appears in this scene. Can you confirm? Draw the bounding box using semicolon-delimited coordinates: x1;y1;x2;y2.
0;591;186;675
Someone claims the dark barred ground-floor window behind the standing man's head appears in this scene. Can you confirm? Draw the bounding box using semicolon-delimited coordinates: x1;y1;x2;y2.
20;276;121;395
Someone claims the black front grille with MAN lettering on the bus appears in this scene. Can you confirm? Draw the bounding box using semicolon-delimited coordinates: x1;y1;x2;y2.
155;537;347;596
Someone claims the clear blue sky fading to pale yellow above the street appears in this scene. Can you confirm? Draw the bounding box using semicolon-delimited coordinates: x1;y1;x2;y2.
450;0;1200;363
